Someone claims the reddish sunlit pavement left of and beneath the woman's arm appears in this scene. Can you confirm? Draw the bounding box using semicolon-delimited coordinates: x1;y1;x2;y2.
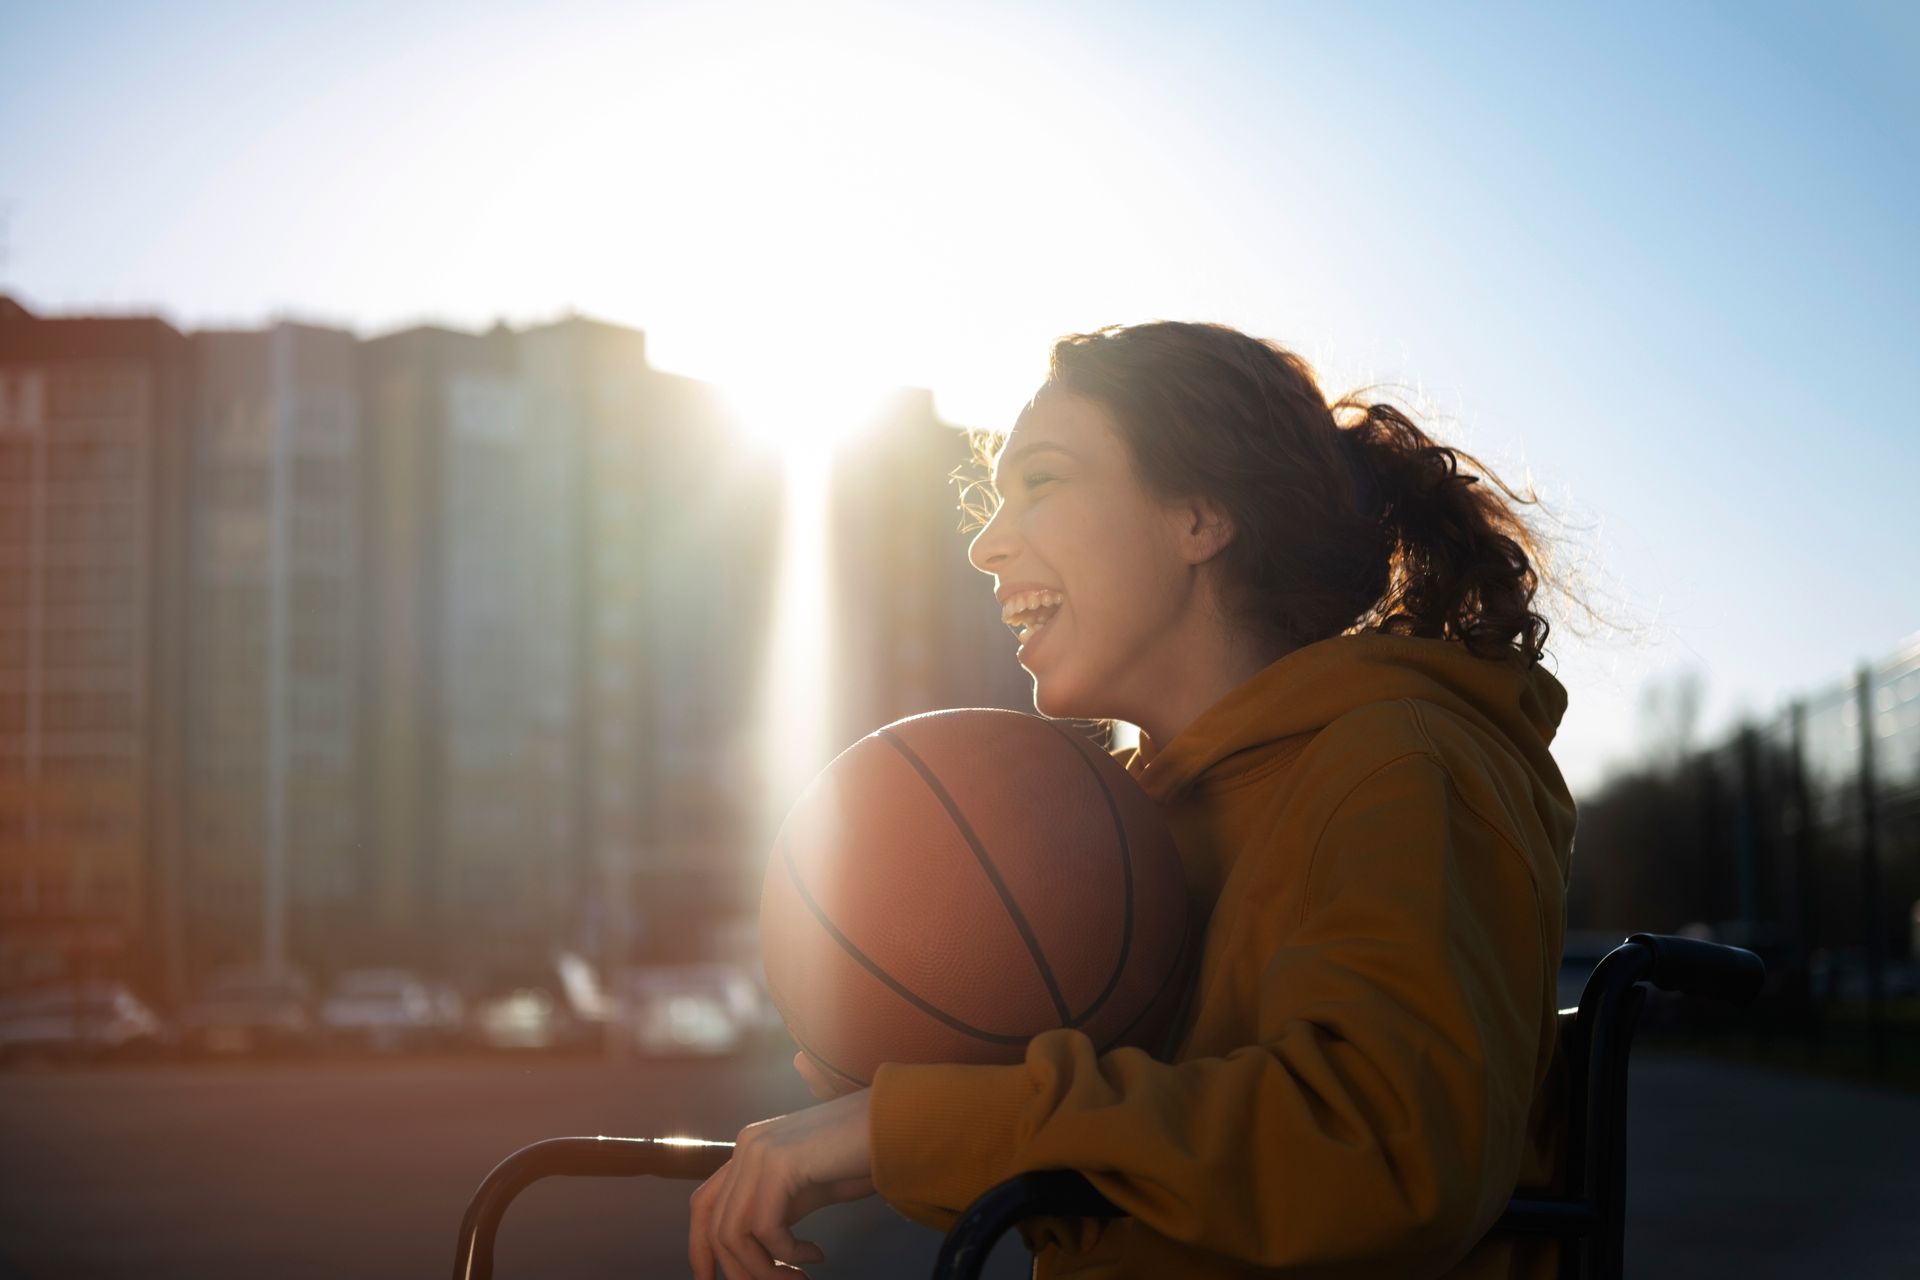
0;1057;1025;1280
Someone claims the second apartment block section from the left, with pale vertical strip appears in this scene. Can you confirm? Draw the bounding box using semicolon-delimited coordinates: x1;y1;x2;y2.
180;322;359;977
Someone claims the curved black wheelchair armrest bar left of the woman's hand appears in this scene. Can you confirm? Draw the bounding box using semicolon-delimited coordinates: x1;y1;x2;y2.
453;1138;733;1280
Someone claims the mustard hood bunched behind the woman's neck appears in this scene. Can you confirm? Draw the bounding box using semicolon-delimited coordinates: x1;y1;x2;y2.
1125;635;1574;848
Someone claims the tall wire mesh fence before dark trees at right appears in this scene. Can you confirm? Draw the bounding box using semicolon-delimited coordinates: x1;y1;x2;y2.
1569;637;1920;1061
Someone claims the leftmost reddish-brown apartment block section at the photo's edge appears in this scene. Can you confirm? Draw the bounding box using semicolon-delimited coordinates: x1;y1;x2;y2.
0;297;192;992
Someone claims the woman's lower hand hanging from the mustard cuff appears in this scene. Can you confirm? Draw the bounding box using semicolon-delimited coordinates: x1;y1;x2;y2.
687;1073;874;1280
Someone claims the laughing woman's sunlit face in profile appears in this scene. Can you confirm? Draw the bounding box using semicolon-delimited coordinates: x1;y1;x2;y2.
968;388;1198;723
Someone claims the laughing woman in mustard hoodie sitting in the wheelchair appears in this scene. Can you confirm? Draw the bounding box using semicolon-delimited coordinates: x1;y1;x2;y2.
689;324;1574;1280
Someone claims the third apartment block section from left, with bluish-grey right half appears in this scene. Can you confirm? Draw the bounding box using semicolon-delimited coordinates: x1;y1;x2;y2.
357;328;574;967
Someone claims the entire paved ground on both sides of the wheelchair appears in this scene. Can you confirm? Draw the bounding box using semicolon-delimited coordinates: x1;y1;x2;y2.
0;1054;1920;1280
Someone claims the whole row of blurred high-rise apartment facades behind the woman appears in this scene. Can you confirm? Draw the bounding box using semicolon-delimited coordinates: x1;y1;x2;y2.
0;303;1031;1000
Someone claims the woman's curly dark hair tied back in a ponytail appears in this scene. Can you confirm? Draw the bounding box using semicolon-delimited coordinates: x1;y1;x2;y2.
962;320;1549;664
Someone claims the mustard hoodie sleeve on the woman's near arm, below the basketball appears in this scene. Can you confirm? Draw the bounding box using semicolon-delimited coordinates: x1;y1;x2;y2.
870;754;1548;1274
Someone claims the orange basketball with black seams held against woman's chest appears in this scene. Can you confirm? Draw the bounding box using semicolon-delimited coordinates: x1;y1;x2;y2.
760;708;1194;1086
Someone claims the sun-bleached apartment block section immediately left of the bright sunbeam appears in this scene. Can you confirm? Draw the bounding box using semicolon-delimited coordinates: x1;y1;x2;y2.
520;319;780;956
